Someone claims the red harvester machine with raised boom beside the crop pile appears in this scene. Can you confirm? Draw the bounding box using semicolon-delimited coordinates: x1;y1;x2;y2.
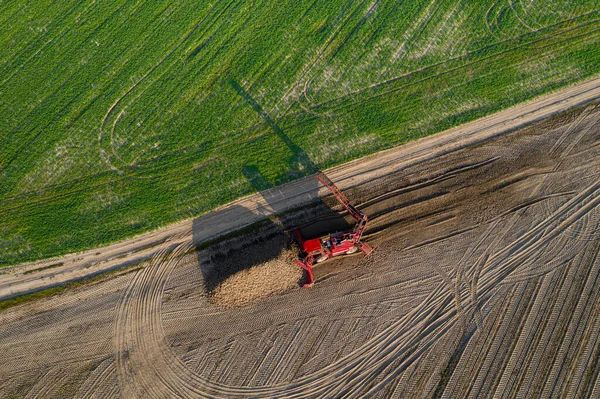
292;172;375;287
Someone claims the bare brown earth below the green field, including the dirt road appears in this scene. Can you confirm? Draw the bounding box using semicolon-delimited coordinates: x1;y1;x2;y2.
0;79;600;398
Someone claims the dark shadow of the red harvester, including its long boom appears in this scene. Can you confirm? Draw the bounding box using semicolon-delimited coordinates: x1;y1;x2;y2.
193;79;351;294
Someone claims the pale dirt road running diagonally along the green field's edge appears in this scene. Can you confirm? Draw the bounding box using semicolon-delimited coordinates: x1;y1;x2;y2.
0;77;600;300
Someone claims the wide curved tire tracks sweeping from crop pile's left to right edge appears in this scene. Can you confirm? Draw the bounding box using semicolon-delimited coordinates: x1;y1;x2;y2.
117;170;600;396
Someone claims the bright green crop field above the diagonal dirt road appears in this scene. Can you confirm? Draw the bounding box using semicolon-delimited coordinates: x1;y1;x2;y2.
0;0;600;265
